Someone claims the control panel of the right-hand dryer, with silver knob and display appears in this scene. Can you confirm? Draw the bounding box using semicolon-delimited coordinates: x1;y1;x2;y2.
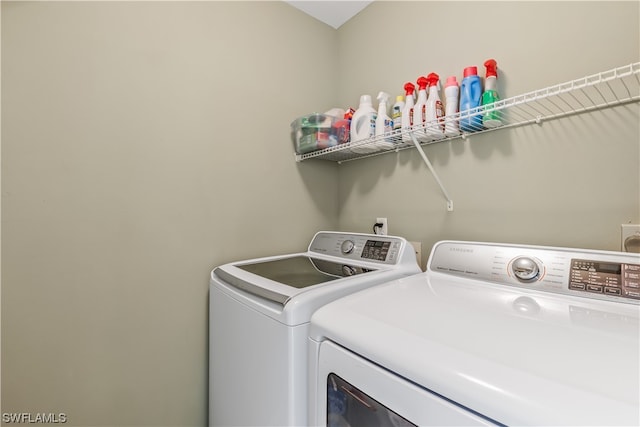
427;241;640;304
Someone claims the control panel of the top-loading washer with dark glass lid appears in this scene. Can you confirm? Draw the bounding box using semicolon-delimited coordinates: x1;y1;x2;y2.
309;232;408;265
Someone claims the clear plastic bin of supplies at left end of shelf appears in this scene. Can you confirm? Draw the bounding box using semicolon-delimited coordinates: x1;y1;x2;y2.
291;113;342;154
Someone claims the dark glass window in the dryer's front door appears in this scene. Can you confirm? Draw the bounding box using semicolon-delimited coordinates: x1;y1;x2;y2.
327;374;415;427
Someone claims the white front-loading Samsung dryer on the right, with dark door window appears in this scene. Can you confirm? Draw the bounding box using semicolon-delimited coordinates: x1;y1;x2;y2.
308;241;640;427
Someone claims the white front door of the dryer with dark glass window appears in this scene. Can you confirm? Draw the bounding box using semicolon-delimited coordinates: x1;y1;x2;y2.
313;341;495;427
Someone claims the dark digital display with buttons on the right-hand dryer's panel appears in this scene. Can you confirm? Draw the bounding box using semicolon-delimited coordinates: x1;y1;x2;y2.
569;259;640;299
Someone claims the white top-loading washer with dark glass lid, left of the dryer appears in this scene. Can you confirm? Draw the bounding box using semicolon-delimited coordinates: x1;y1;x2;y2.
209;232;421;426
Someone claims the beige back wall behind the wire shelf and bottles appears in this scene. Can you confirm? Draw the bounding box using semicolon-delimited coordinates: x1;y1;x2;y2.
338;2;640;266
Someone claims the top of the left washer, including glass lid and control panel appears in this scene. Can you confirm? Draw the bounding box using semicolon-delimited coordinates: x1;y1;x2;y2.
210;231;421;325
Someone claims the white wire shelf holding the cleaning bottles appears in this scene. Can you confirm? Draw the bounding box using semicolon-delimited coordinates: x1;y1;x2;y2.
296;62;640;163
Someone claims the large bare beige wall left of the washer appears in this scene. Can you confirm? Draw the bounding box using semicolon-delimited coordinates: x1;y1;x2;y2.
2;1;338;426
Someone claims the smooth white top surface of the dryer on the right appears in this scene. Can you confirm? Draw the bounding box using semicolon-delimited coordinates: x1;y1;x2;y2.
310;273;640;425
